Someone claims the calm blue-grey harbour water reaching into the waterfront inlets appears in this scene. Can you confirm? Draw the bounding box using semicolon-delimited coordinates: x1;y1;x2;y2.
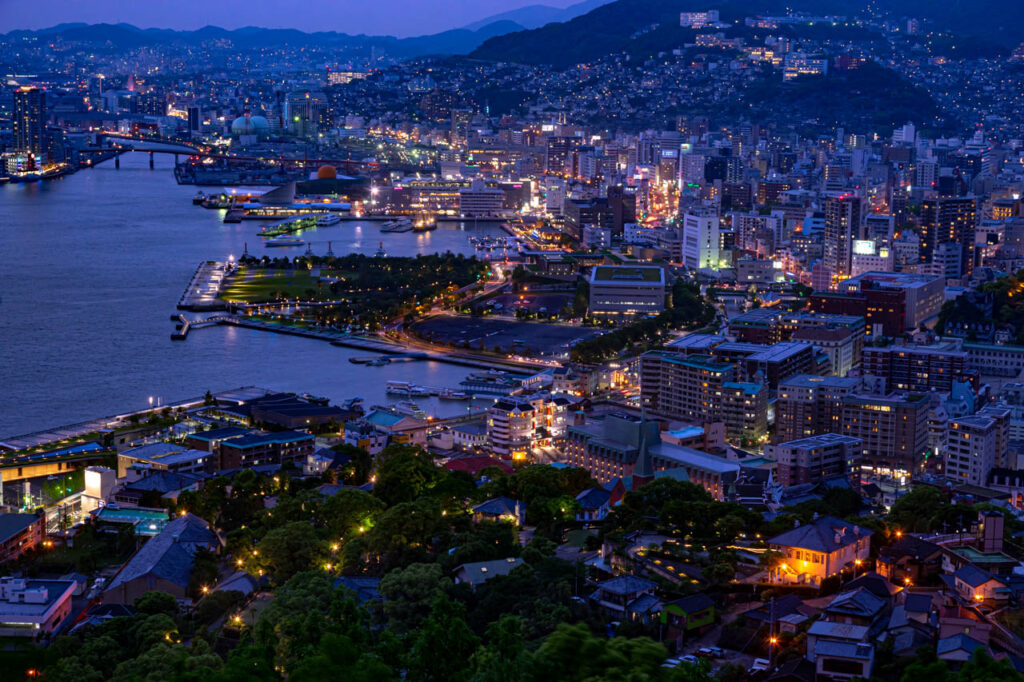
0;154;500;438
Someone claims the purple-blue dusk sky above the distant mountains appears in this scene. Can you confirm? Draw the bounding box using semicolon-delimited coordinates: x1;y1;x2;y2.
0;0;577;37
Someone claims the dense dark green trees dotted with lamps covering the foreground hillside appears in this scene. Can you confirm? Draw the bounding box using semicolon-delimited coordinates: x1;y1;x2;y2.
19;438;1017;682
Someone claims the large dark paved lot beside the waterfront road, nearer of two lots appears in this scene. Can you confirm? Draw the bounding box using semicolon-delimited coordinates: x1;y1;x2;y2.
414;315;602;355
